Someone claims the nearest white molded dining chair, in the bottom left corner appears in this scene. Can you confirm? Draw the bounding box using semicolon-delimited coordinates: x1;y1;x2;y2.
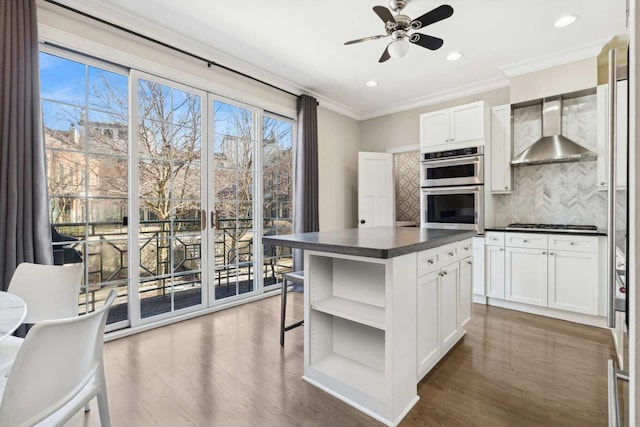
0;289;116;427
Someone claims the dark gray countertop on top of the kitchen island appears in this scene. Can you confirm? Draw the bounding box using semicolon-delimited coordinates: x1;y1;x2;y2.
262;227;476;259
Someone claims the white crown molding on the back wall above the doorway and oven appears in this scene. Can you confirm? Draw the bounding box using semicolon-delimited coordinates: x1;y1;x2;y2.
360;77;509;120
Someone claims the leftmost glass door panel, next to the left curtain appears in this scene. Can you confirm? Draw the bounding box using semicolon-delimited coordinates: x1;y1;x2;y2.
40;52;130;330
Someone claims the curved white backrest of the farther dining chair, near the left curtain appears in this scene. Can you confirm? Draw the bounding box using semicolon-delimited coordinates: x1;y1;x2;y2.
7;262;83;323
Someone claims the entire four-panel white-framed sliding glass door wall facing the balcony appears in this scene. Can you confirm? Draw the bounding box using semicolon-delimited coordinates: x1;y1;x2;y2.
40;47;295;330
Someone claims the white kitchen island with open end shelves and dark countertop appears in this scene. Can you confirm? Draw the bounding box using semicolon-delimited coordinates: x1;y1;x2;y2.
262;227;475;425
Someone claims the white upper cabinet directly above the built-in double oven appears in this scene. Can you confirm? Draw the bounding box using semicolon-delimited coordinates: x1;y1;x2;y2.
420;101;489;150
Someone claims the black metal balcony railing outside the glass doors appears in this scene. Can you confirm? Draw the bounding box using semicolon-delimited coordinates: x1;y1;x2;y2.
53;218;291;318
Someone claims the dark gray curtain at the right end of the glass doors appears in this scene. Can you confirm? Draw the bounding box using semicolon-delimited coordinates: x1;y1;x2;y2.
293;95;320;271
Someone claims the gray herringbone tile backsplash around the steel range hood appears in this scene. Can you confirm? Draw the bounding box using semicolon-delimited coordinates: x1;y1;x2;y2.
496;95;607;228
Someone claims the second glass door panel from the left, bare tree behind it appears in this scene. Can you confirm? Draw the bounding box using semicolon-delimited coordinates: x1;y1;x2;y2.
137;78;203;319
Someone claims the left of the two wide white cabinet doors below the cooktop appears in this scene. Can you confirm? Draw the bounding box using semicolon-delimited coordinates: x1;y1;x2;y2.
504;247;547;307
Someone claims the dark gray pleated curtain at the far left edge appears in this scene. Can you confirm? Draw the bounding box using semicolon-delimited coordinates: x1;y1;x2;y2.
0;0;53;290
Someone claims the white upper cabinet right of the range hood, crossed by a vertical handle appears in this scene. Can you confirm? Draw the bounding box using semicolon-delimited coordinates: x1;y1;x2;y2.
597;80;628;190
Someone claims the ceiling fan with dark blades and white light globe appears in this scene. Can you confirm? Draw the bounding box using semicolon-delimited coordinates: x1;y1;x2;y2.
345;0;453;62
